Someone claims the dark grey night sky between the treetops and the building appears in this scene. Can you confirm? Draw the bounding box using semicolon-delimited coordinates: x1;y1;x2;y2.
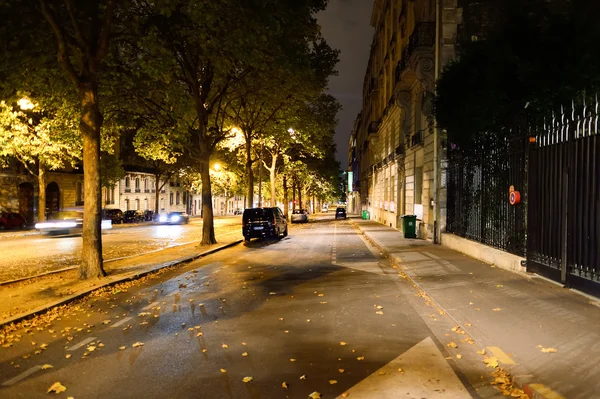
319;0;373;170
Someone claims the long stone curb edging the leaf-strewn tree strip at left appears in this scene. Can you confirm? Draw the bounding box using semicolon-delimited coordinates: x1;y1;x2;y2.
0;240;243;328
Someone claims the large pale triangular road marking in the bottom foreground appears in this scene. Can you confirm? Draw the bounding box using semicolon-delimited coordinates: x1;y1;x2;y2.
338;337;471;399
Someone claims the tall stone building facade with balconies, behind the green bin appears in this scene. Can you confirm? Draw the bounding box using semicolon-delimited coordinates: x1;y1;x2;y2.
349;0;461;239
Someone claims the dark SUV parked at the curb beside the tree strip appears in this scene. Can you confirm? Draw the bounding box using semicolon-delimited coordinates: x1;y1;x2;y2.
242;208;287;241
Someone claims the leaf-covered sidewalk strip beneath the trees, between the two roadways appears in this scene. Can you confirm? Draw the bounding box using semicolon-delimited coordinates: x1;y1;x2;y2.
0;233;242;327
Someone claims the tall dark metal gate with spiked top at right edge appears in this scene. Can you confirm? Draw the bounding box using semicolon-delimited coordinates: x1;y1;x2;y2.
527;99;600;294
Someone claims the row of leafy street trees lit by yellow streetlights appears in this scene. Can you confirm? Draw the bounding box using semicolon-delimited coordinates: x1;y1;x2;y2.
0;0;339;279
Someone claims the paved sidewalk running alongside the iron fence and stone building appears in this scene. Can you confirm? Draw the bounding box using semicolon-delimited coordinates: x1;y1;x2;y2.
350;217;600;399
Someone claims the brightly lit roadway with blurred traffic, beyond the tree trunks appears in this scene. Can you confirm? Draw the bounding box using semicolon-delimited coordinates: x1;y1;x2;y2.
0;216;241;281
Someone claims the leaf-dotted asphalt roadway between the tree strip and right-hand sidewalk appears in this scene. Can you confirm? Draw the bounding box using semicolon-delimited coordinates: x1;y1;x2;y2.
0;217;482;399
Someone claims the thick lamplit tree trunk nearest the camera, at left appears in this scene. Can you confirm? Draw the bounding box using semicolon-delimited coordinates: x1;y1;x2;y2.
79;82;106;280
